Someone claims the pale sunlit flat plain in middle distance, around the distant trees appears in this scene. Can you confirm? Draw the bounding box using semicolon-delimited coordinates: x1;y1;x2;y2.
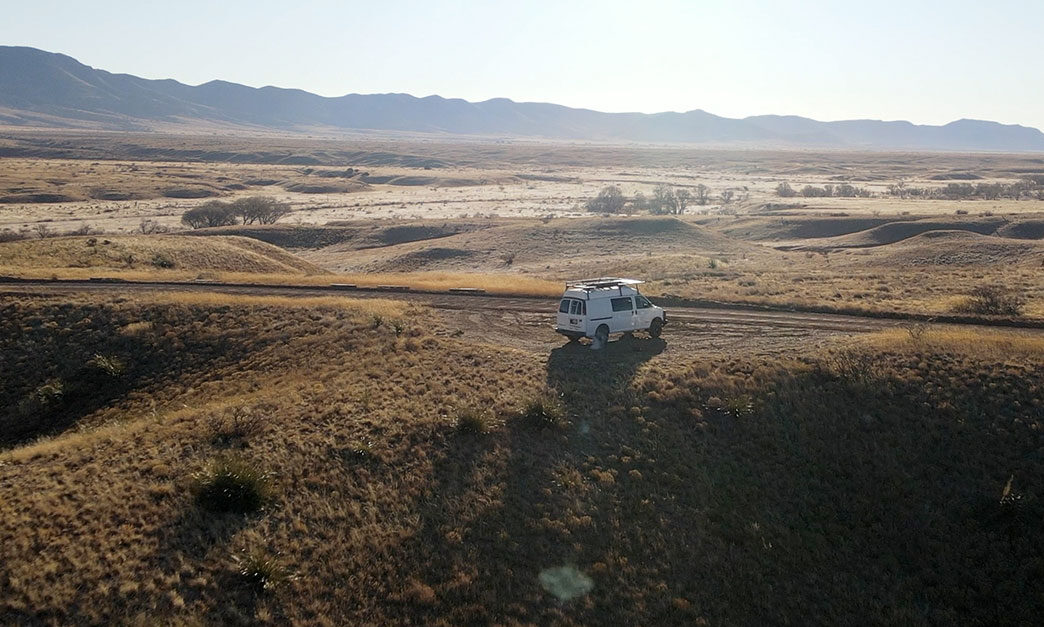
0;155;1044;233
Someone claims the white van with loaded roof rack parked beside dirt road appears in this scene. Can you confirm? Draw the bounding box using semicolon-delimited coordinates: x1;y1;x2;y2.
554;276;667;348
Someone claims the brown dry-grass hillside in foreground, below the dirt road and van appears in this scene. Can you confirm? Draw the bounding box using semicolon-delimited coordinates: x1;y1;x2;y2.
0;294;1044;625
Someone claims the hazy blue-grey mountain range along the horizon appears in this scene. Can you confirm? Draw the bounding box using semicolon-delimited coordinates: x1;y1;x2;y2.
0;46;1044;151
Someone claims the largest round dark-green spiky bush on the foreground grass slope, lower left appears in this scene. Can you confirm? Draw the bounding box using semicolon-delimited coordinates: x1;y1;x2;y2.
193;457;272;513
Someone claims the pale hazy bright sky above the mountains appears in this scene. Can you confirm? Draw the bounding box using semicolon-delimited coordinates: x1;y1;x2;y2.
0;0;1044;128
